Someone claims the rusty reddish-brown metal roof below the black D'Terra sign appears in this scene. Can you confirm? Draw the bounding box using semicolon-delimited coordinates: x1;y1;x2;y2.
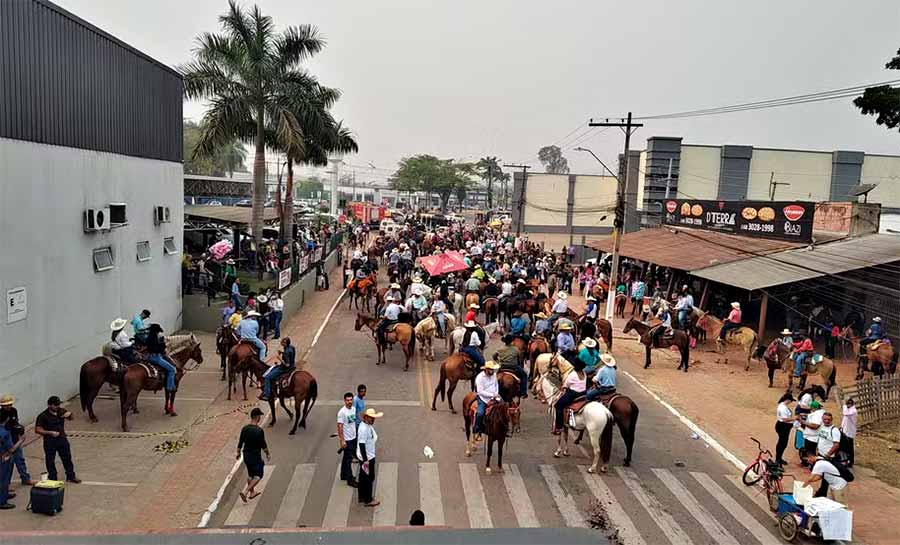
590;227;802;274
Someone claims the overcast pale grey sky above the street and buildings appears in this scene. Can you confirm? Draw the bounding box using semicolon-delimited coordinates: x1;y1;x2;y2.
56;0;900;181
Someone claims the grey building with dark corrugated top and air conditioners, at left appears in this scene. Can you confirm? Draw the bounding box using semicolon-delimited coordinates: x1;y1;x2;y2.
0;0;183;419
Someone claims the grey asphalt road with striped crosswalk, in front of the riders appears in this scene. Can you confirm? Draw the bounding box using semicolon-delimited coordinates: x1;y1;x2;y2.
210;288;779;544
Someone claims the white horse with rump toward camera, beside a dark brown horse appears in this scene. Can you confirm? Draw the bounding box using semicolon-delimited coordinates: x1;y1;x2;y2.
539;360;615;473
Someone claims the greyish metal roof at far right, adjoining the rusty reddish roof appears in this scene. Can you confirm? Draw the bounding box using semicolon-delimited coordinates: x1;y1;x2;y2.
691;234;900;290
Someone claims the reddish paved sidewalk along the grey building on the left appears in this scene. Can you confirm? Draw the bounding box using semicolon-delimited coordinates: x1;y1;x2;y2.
0;267;342;531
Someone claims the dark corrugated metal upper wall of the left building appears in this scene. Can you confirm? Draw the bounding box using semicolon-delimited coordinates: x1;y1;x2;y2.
0;0;182;162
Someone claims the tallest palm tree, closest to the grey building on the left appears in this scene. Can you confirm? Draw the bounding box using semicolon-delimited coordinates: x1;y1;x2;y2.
180;0;325;247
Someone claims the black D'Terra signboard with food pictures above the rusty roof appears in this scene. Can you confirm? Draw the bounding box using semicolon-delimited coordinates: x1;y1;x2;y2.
663;199;815;242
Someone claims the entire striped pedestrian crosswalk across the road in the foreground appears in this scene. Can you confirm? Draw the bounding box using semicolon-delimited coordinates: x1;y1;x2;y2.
221;462;779;545
